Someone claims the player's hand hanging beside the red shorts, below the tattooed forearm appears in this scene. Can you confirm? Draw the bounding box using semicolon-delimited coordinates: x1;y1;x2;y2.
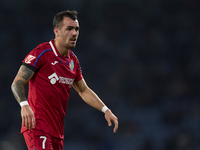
21;105;36;129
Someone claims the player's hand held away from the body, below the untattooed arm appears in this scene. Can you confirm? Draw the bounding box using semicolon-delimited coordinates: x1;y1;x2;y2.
105;109;118;133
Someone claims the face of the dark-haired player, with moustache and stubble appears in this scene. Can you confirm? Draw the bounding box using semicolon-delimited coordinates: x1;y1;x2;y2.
54;17;79;49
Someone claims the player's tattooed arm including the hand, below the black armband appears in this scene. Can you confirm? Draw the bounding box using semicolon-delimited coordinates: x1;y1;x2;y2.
11;65;35;129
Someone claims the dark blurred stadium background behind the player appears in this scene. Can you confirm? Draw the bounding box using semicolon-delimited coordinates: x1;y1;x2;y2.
0;0;200;150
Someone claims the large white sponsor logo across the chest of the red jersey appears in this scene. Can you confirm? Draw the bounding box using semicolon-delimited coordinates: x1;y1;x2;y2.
48;72;74;86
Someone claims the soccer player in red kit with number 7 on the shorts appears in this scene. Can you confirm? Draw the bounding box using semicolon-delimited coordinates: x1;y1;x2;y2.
11;10;118;150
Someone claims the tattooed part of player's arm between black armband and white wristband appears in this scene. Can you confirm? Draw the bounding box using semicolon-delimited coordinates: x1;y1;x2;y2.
11;65;34;103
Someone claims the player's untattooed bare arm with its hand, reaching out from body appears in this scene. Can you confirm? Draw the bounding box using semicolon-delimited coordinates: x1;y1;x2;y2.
73;79;118;133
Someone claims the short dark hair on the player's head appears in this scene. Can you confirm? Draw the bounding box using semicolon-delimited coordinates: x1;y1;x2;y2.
53;10;78;28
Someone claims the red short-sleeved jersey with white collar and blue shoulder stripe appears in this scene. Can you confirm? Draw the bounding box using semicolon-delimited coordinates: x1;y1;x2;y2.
21;40;83;139
